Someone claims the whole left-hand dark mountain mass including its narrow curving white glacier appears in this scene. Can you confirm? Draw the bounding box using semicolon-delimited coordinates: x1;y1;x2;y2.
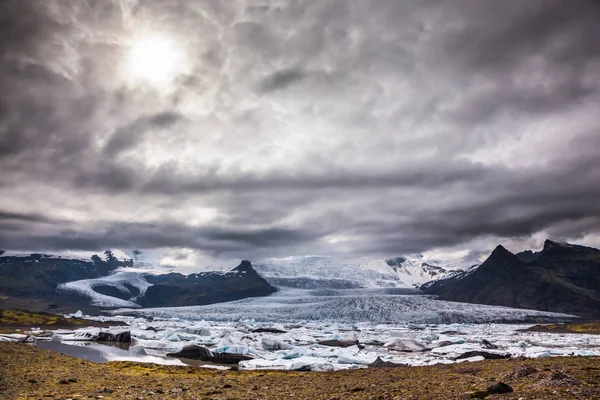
0;250;276;310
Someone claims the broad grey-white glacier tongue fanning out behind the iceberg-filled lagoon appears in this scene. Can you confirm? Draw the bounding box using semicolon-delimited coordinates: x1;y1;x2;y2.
116;288;572;324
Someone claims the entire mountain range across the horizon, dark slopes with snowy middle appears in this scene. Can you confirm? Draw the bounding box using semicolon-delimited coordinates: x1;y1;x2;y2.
0;240;600;318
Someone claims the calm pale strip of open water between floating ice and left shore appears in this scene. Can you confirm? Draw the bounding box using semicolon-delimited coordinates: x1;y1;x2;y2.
35;340;230;369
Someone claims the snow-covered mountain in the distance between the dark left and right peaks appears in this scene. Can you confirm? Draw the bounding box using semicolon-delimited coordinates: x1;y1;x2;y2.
255;255;478;289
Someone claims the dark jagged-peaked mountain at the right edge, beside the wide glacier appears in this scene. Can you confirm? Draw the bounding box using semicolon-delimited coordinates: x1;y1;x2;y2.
422;240;600;318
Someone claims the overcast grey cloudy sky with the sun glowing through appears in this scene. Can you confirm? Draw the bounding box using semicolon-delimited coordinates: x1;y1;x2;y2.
0;0;600;266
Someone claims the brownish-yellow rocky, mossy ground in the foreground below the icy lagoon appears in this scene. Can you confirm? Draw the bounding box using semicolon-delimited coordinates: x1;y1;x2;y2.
0;343;600;400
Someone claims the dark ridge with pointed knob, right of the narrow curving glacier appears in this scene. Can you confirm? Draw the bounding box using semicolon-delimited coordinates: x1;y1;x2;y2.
138;261;276;307
